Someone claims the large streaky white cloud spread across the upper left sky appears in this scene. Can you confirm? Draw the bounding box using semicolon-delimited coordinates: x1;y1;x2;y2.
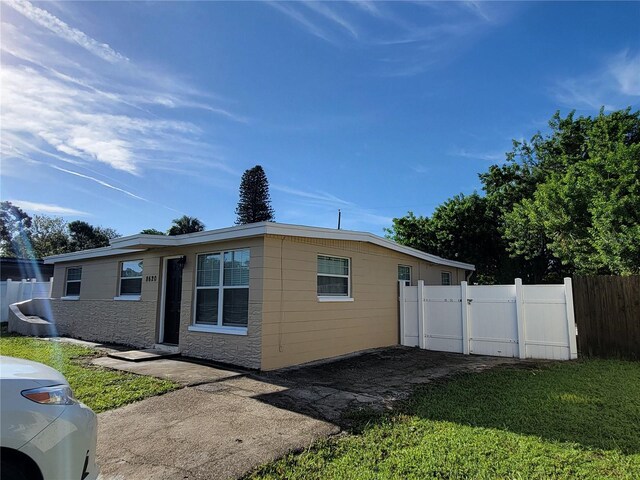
0;0;249;182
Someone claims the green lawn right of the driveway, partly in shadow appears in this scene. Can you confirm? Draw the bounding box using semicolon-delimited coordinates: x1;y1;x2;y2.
251;360;640;479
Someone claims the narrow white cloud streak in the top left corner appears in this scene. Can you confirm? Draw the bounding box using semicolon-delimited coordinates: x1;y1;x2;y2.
6;0;129;63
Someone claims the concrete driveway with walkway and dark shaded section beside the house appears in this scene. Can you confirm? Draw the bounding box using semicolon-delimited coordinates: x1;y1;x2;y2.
96;347;517;480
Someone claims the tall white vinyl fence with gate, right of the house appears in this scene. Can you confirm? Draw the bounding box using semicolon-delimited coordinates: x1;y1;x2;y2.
400;278;578;360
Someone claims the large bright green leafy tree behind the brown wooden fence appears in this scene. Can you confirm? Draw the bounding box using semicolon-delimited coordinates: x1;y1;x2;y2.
504;109;640;275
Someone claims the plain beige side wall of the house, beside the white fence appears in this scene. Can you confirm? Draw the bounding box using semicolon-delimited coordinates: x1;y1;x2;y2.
262;235;464;370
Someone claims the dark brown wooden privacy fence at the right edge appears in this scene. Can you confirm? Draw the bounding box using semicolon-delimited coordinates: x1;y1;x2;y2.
573;275;640;360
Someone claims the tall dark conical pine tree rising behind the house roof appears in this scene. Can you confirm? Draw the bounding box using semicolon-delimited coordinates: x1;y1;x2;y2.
236;165;275;225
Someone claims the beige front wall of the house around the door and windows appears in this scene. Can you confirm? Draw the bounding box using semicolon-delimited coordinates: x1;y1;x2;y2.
52;237;264;369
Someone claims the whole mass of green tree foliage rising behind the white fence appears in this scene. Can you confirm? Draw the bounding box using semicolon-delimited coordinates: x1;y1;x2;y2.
387;109;640;283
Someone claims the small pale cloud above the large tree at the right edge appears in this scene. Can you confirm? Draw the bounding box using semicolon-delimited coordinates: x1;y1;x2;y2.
551;50;640;110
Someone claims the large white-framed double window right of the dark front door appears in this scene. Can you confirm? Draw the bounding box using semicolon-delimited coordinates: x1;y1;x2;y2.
194;249;250;331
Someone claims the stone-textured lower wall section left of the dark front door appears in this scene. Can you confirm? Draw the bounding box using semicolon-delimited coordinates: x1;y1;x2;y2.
46;299;156;347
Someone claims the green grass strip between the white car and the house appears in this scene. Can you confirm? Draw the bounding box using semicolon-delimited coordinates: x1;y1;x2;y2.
0;335;178;413
